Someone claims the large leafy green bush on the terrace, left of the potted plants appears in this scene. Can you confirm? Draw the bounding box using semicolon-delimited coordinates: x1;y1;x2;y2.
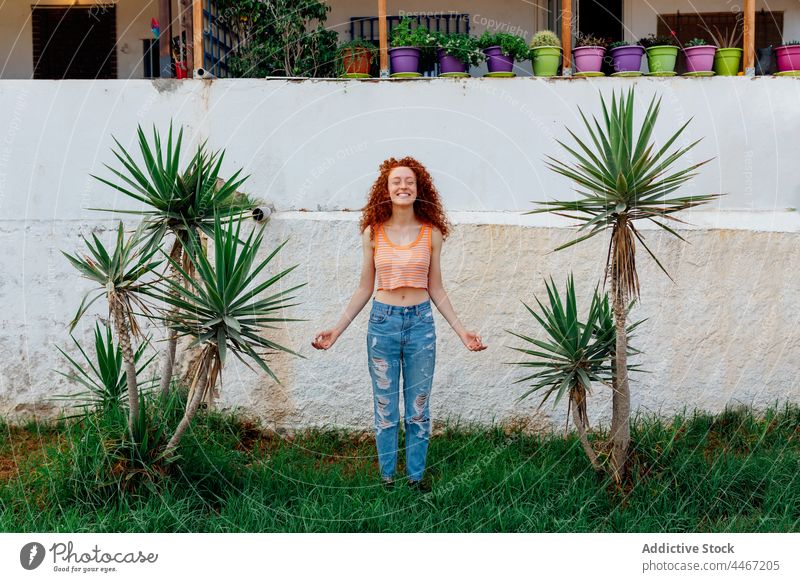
215;0;339;77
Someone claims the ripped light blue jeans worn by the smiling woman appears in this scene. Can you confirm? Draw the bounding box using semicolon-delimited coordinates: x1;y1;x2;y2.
367;299;436;481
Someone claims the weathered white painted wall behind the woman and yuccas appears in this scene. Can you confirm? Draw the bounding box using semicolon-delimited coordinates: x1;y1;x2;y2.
0;78;800;434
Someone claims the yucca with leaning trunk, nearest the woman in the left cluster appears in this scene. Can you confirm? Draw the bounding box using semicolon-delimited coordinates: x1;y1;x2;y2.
141;218;305;456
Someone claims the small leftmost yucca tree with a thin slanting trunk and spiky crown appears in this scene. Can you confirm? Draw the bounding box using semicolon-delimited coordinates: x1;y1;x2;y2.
61;222;162;441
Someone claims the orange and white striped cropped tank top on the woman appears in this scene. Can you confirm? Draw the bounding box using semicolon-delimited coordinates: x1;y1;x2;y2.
372;224;433;291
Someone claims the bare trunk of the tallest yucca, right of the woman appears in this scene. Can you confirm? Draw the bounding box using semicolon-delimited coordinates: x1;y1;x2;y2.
611;269;631;485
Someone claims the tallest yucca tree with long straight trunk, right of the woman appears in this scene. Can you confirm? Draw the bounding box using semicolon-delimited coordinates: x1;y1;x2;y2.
526;88;719;484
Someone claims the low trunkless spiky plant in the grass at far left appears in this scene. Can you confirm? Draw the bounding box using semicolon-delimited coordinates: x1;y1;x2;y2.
53;323;157;419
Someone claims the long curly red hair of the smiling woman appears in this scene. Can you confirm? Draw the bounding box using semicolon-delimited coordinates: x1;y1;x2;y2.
359;156;450;238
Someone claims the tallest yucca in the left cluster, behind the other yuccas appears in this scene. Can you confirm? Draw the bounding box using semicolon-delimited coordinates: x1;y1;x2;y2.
92;122;255;400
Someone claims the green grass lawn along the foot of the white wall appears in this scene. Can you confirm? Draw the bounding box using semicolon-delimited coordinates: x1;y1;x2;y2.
0;406;800;532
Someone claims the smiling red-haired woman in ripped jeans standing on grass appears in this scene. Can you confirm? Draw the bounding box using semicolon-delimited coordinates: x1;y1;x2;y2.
311;157;486;491
